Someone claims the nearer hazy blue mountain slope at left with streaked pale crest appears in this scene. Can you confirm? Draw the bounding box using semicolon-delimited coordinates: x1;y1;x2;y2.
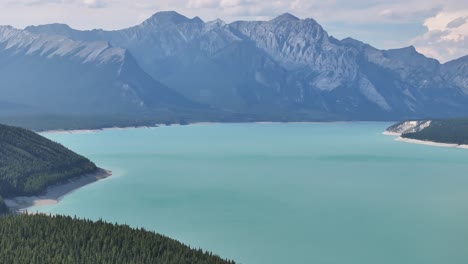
0;27;212;128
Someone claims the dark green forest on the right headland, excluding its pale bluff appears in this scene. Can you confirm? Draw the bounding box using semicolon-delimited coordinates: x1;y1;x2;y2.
402;118;468;145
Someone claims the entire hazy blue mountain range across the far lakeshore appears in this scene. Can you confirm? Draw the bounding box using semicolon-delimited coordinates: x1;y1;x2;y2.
0;12;468;128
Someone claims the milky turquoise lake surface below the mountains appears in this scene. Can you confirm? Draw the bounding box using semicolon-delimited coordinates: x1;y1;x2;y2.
33;123;468;264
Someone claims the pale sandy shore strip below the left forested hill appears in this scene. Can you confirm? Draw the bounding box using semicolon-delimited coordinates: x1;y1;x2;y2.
5;168;112;213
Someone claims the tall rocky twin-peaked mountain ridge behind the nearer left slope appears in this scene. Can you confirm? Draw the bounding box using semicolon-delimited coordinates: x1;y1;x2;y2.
12;12;468;120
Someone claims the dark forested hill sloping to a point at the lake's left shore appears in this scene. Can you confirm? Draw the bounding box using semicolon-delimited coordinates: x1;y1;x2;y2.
0;125;97;198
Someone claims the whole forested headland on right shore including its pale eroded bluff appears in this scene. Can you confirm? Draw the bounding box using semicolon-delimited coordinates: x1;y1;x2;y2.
389;118;468;145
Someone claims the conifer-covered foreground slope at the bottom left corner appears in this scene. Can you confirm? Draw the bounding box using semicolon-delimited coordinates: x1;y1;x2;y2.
0;215;234;264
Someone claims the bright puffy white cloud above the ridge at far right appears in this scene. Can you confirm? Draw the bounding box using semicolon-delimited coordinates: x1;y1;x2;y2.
412;9;468;62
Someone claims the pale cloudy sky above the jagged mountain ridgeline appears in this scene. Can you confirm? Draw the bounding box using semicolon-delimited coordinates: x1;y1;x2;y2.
0;0;468;62
